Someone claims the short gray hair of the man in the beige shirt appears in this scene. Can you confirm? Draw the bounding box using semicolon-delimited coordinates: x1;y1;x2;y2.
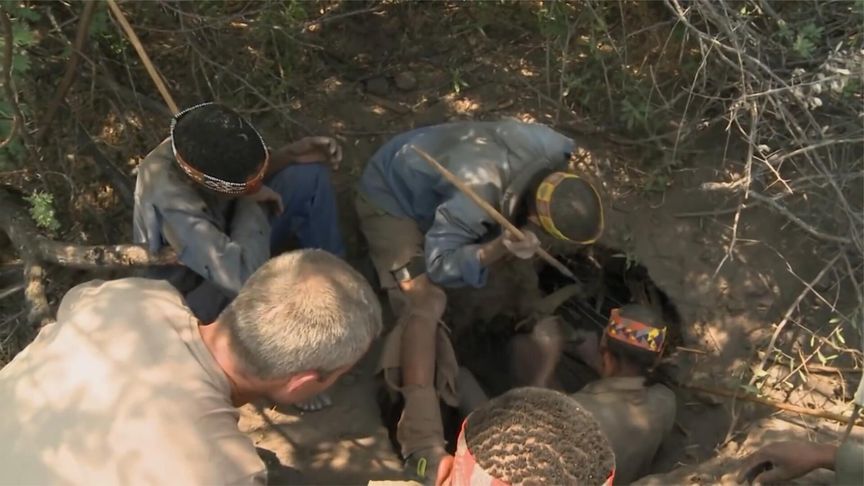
219;250;381;379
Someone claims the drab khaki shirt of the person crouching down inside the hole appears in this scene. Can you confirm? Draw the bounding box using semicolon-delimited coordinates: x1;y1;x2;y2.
572;377;676;484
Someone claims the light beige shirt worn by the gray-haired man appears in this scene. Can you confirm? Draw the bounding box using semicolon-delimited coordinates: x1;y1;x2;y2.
0;278;266;485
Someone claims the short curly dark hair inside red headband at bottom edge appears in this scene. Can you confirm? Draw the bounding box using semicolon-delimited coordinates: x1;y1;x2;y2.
465;387;615;486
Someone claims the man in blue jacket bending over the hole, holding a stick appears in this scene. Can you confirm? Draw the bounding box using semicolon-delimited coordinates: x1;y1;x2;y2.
357;121;603;479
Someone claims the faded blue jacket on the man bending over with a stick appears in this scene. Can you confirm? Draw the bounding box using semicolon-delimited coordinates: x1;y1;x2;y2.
360;120;574;287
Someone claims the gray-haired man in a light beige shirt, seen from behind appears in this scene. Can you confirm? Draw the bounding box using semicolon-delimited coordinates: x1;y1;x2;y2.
0;250;381;485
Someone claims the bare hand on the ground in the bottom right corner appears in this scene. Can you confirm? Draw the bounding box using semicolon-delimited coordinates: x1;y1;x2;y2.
737;440;837;484
